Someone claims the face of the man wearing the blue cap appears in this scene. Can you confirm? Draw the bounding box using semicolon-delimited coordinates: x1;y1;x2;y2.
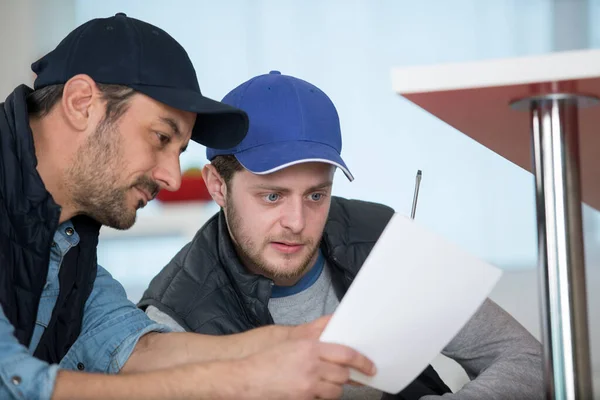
224;163;335;285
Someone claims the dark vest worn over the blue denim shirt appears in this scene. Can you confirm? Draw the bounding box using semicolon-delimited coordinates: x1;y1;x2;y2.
0;86;100;363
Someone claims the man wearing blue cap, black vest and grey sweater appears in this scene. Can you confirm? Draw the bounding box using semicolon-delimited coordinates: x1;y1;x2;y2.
143;71;543;399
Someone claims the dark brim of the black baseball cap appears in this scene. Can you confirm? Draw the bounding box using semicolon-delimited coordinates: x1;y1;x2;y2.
128;85;248;149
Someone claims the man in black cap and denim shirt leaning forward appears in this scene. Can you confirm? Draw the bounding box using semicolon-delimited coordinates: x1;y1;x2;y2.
0;14;373;399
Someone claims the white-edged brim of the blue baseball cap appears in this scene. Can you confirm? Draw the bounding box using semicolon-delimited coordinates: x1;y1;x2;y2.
230;141;354;181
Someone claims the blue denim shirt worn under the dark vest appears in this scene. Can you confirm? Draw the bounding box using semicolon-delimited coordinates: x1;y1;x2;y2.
0;221;170;400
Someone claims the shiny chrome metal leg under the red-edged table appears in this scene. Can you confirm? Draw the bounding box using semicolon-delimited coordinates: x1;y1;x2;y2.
512;94;600;400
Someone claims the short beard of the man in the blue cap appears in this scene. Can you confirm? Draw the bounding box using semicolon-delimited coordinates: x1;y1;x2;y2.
223;193;319;282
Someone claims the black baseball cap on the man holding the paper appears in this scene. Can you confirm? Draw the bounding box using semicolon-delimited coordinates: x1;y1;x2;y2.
31;13;248;148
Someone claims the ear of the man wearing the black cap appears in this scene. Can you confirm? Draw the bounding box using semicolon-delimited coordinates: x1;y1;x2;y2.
61;75;104;131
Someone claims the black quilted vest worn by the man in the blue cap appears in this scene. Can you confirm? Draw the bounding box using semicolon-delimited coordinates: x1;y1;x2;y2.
138;197;450;400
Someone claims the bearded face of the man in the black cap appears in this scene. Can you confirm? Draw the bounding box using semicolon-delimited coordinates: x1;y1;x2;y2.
64;94;196;229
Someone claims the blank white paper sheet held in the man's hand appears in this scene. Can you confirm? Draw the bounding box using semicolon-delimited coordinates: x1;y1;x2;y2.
320;214;502;393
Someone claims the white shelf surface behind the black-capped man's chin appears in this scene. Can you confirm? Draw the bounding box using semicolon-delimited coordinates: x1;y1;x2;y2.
100;202;219;240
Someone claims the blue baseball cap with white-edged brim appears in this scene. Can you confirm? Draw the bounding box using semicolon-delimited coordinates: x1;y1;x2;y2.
206;71;354;181
